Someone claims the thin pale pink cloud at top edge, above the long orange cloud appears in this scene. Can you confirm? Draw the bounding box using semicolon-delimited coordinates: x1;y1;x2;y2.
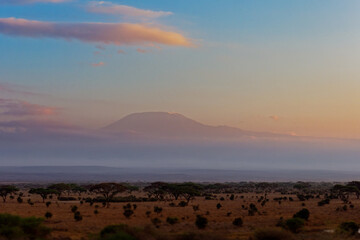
86;1;173;19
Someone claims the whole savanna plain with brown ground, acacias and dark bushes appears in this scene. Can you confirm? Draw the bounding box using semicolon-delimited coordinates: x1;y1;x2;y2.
0;181;360;240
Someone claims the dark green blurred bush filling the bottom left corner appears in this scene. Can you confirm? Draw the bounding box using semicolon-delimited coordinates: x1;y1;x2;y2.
0;214;51;239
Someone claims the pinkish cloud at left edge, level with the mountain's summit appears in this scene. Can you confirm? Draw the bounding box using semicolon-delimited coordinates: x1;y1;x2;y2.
0;98;57;117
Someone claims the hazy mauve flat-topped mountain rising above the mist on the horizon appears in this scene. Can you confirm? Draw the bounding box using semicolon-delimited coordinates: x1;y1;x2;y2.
102;112;291;139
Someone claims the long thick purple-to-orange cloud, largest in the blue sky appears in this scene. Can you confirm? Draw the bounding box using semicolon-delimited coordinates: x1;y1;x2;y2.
0;18;192;47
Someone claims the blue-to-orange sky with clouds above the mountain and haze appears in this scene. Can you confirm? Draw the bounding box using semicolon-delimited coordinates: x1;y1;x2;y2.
0;0;360;139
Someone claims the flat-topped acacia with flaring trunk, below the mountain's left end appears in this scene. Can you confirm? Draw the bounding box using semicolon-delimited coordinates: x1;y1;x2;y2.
90;183;127;207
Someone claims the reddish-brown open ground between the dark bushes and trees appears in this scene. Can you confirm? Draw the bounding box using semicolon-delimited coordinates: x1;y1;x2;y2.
0;193;360;240
